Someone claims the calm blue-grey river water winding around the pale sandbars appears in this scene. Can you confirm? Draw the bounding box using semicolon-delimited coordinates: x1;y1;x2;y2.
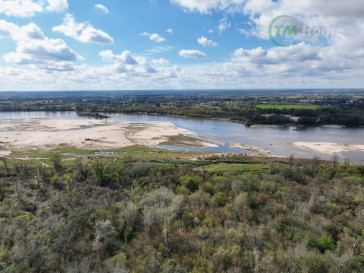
0;112;364;163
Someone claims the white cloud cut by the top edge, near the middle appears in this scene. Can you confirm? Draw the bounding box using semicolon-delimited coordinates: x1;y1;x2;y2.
170;0;245;14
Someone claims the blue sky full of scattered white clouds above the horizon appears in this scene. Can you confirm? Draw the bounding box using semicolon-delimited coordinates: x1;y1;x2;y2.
0;0;364;91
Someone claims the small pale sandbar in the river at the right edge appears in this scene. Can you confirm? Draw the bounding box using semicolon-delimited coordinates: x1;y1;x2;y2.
284;142;364;154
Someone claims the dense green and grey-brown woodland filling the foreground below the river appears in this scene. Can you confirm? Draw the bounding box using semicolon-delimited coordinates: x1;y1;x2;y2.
0;151;364;273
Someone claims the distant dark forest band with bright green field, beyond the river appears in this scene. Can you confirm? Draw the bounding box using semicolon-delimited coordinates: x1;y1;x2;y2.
0;90;364;127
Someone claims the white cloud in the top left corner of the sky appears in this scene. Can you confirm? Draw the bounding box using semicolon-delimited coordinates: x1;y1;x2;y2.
0;0;43;17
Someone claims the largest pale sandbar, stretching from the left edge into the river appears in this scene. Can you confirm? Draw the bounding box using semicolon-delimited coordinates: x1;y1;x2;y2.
0;119;214;155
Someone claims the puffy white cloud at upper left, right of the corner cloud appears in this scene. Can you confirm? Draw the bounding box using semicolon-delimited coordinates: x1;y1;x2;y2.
53;14;114;44
